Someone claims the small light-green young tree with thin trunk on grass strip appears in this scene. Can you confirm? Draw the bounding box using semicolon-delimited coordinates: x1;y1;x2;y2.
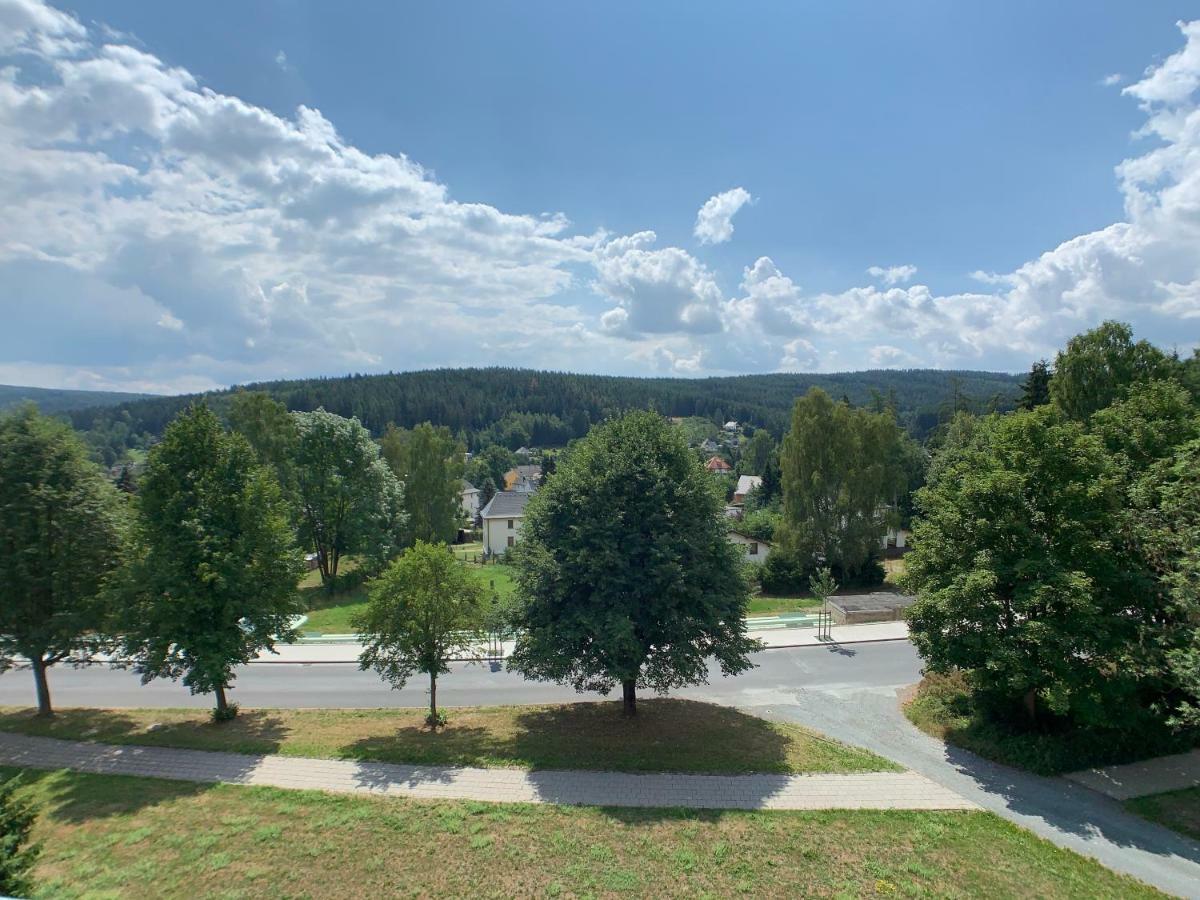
355;540;485;728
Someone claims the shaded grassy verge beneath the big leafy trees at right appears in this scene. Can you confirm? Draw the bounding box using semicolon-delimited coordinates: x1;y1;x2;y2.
904;674;1193;775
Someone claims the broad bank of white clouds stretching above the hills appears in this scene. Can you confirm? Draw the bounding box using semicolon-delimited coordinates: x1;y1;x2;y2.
0;0;1200;391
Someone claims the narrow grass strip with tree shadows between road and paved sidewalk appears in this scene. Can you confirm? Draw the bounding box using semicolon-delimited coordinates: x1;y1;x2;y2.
0;697;899;773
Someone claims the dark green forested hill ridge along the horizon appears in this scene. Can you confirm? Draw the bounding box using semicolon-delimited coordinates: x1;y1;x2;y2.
71;368;1020;446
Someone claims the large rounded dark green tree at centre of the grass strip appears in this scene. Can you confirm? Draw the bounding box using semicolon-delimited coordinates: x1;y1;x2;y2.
509;412;757;715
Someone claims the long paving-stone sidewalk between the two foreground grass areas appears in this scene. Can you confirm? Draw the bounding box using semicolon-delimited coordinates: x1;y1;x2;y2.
0;733;977;810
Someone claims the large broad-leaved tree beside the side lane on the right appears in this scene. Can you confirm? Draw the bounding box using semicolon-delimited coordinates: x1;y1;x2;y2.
905;407;1148;726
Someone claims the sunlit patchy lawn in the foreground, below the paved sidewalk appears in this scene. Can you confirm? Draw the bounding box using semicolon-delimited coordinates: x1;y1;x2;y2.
0;769;1157;900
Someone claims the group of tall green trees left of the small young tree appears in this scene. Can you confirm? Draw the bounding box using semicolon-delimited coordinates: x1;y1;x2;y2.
0;391;463;719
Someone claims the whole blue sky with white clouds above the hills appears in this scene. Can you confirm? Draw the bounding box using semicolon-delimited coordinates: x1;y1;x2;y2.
0;0;1200;392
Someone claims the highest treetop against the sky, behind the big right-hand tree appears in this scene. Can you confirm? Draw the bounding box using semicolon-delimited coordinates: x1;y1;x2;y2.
1050;322;1174;421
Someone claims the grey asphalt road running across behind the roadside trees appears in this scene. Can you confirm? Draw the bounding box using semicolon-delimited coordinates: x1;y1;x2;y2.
0;641;920;708
